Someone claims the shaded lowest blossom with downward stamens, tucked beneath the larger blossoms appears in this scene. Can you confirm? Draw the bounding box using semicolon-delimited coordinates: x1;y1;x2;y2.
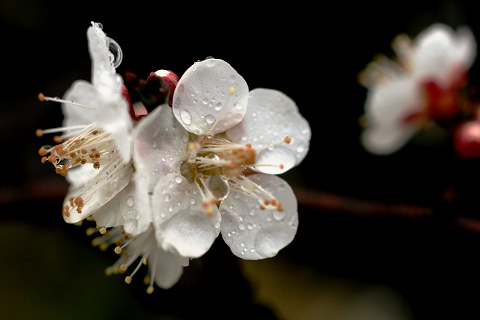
92;227;189;293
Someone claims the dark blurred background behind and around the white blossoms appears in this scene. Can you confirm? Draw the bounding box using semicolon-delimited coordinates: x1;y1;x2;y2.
0;0;480;320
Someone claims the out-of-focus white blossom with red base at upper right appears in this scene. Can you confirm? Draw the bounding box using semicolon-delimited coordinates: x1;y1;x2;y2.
361;24;476;154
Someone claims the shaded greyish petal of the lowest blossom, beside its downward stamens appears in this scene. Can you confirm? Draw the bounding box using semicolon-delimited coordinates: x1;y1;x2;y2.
153;248;183;289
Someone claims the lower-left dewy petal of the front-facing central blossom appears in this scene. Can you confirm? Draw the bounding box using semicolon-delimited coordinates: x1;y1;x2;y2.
152;174;220;258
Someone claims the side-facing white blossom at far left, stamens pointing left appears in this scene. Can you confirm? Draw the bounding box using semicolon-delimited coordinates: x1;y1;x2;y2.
39;22;133;223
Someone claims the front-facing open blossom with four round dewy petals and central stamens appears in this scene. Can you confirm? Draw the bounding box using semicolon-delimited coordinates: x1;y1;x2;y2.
152;59;311;259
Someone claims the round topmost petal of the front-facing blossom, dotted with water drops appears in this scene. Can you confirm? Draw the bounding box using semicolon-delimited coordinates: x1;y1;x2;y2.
173;59;248;135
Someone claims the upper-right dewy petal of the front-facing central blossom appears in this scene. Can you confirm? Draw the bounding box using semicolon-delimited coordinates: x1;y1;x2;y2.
226;89;311;174
